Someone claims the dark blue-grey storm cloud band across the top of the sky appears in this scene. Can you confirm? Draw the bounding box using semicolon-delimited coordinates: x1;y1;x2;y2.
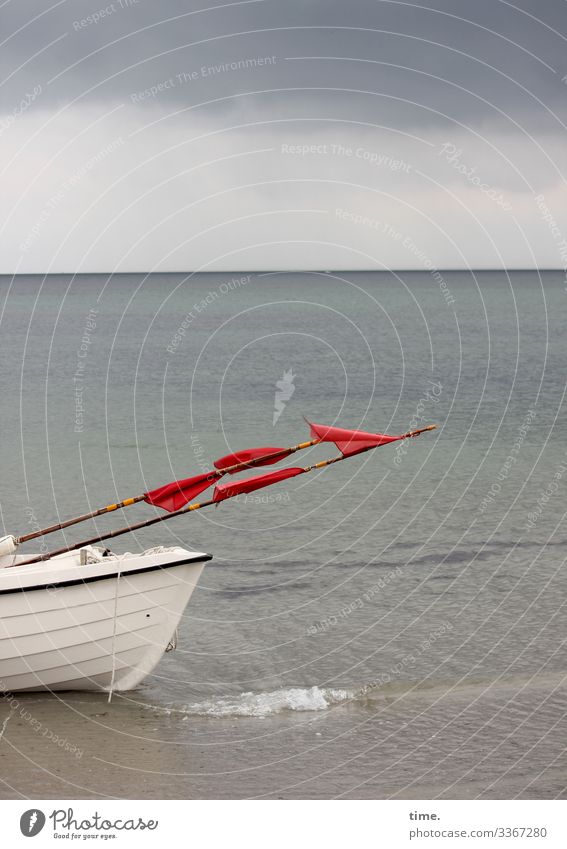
0;0;567;131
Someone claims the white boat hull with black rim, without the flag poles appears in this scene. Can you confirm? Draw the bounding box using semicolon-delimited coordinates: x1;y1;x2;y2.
0;546;211;694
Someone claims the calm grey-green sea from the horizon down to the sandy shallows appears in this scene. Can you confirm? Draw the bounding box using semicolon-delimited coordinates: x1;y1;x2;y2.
0;272;567;798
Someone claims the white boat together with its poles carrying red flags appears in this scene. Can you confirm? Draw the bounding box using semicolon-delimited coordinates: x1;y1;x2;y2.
0;423;435;695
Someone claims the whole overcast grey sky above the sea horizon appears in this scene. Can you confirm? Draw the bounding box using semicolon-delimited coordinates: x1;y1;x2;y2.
0;0;567;273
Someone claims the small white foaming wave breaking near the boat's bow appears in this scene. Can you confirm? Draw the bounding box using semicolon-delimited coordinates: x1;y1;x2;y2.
186;687;352;717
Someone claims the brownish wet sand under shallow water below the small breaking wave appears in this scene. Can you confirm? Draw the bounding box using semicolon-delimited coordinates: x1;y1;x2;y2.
0;675;567;799
